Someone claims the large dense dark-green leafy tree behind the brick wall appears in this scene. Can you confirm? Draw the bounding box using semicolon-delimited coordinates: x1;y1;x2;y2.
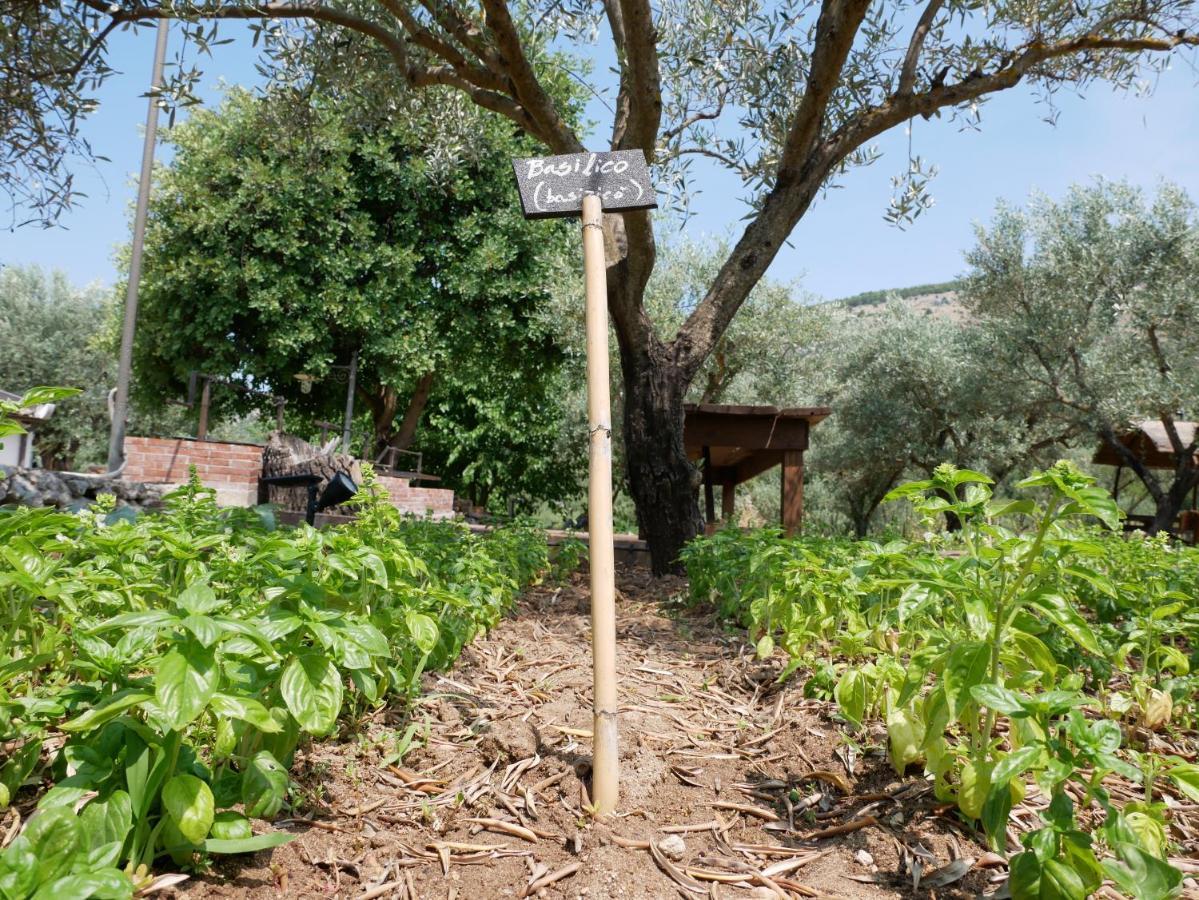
135;91;576;508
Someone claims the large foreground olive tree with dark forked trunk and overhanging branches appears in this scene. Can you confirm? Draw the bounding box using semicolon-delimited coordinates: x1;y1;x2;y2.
9;0;1199;572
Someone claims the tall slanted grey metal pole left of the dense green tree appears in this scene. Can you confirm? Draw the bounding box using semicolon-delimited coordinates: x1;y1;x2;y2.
108;19;170;472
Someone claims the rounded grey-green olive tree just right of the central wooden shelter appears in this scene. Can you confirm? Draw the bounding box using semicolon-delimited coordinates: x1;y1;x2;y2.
812;301;1077;537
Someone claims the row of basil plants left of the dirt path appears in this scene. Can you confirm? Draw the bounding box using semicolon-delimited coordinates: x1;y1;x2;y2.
0;473;548;900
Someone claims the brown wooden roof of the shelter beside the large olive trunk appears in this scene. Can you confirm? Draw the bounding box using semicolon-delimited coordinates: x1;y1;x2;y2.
683;403;831;484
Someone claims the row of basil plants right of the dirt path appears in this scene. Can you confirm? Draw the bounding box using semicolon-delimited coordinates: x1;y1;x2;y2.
683;463;1199;900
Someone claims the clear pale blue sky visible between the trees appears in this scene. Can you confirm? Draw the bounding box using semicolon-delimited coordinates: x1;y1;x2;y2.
0;23;1199;297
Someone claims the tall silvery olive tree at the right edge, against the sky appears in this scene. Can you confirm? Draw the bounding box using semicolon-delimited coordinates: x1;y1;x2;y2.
964;182;1199;532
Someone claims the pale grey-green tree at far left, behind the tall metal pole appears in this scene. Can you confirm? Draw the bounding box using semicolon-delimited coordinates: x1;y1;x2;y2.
0;266;116;469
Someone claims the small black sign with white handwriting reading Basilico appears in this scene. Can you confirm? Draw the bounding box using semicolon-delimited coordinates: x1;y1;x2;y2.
512;150;658;219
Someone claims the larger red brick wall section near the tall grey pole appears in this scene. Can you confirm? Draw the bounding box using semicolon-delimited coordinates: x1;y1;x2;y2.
122;437;263;506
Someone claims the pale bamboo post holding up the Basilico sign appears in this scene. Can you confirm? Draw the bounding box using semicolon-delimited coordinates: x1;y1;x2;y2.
583;193;620;815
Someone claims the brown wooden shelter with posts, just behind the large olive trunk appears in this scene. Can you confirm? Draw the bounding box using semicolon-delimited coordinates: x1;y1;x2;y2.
683;403;830;534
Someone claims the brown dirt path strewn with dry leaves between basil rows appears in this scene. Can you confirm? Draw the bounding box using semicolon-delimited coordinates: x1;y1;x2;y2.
182;570;994;900
